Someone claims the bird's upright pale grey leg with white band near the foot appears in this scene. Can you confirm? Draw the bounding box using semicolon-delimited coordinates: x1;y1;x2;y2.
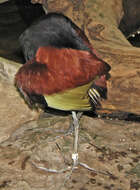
72;111;79;167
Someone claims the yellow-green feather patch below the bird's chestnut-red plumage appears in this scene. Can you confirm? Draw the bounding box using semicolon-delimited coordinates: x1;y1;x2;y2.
44;82;93;111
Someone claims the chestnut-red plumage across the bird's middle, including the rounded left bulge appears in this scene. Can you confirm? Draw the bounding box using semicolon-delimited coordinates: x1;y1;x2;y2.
15;47;109;95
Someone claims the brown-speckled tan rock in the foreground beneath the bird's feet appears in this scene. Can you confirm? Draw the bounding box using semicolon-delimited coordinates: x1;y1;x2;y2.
0;117;140;190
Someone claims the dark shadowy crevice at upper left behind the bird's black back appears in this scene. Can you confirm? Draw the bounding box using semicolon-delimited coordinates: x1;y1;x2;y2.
0;0;45;63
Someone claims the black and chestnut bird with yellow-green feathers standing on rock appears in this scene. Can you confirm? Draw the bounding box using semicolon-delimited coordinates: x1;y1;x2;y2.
15;13;111;167
